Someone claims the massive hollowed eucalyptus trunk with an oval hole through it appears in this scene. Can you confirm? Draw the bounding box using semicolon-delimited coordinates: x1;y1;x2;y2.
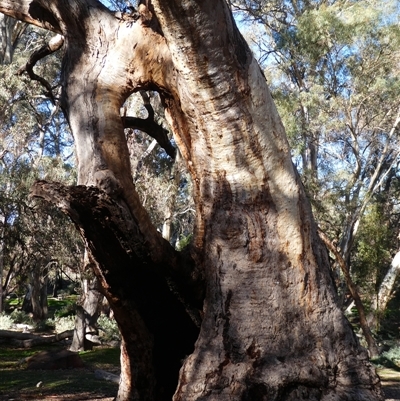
0;0;383;401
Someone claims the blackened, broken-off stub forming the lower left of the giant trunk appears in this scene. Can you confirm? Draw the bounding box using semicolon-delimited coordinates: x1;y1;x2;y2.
33;182;202;400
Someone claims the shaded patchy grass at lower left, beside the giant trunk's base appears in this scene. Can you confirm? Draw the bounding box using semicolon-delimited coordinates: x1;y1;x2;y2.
0;347;119;401
